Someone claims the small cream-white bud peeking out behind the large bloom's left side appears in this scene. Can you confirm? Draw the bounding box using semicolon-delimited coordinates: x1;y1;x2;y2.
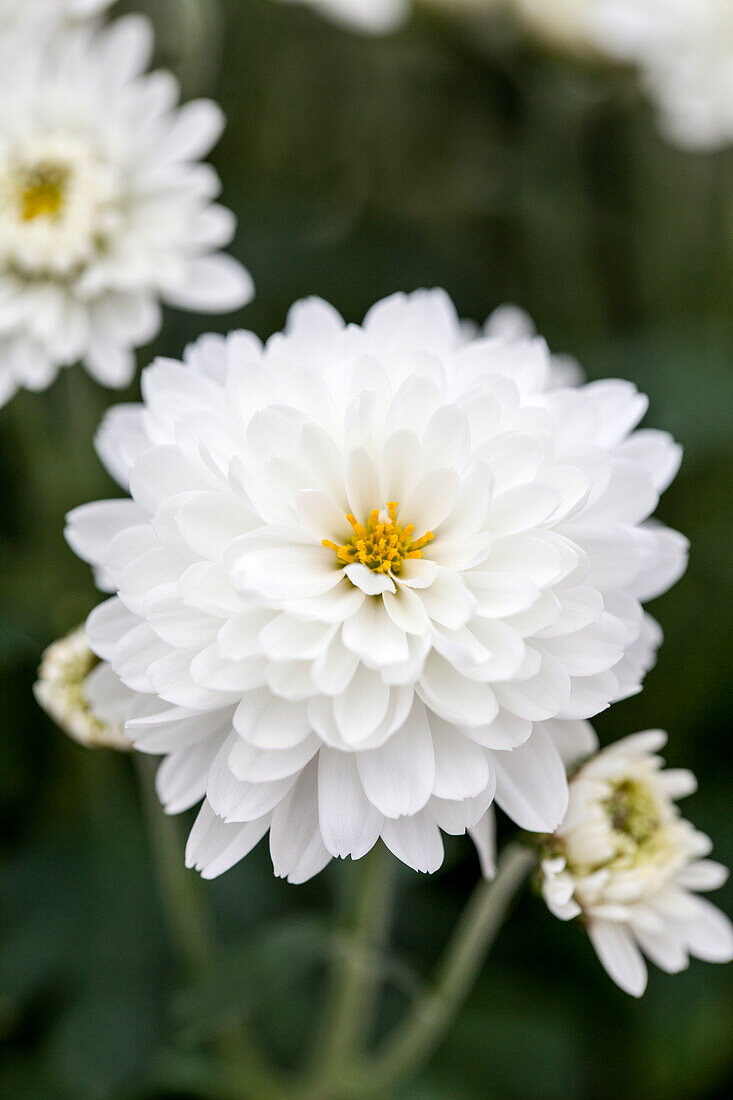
33;629;138;749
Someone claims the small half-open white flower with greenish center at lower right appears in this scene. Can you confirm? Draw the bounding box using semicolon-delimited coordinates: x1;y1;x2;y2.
541;730;733;997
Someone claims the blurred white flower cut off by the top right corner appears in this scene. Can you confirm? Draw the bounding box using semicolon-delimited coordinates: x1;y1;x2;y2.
515;0;733;150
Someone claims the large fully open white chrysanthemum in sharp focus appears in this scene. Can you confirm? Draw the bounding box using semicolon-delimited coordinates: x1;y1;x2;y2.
68;290;686;881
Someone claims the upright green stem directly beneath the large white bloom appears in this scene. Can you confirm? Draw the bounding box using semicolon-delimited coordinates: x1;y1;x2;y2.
314;844;393;1096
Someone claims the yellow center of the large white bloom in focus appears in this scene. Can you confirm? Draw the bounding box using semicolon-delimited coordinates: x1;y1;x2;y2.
322;501;435;573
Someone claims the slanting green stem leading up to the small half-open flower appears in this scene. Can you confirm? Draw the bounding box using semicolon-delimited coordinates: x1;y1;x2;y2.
362;843;537;1096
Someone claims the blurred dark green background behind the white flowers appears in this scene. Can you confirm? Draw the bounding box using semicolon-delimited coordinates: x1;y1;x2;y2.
0;0;733;1100
